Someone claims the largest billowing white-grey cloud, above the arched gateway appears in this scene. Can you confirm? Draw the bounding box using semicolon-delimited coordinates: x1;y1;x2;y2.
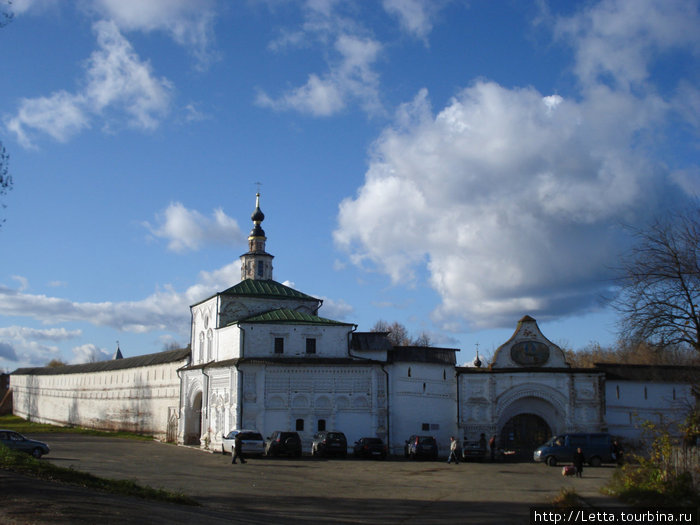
334;2;698;328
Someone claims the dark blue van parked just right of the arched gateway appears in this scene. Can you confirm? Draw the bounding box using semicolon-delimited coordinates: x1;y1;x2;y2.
533;432;616;467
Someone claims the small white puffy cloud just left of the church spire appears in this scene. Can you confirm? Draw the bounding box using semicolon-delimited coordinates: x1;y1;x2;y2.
144;202;244;253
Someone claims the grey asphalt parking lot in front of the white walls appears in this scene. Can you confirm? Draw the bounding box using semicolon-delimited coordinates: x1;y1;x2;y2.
0;434;615;525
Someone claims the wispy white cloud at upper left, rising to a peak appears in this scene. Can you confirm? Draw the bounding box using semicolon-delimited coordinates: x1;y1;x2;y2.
4;21;171;147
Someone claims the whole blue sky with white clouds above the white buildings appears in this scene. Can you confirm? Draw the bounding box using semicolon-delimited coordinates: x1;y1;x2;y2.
0;0;700;370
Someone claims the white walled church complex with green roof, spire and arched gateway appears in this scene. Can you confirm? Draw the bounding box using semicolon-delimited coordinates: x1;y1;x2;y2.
11;194;698;455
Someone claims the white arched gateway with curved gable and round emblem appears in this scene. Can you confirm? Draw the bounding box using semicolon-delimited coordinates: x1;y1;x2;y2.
459;316;604;446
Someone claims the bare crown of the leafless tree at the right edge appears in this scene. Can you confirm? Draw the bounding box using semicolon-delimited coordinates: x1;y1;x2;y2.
614;207;700;353
